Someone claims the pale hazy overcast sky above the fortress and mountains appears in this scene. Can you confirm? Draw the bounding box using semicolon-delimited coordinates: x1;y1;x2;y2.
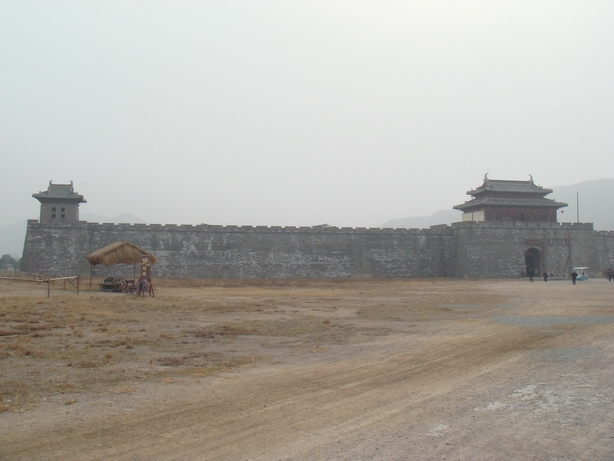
0;0;614;227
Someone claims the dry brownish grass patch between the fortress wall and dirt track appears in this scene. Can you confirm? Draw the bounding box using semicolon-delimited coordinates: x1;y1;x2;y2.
0;279;508;411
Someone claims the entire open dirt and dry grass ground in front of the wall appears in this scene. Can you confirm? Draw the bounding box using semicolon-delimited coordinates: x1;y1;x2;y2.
0;279;614;460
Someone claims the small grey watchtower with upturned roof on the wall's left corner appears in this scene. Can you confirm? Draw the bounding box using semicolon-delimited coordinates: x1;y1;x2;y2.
32;181;87;222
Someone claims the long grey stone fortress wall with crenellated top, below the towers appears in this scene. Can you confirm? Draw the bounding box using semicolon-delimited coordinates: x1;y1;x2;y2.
21;220;614;278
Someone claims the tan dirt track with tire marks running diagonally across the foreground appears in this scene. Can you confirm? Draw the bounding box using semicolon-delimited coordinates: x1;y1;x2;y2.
5;322;588;459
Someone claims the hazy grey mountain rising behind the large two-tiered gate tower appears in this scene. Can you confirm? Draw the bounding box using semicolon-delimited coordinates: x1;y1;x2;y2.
380;179;614;230
